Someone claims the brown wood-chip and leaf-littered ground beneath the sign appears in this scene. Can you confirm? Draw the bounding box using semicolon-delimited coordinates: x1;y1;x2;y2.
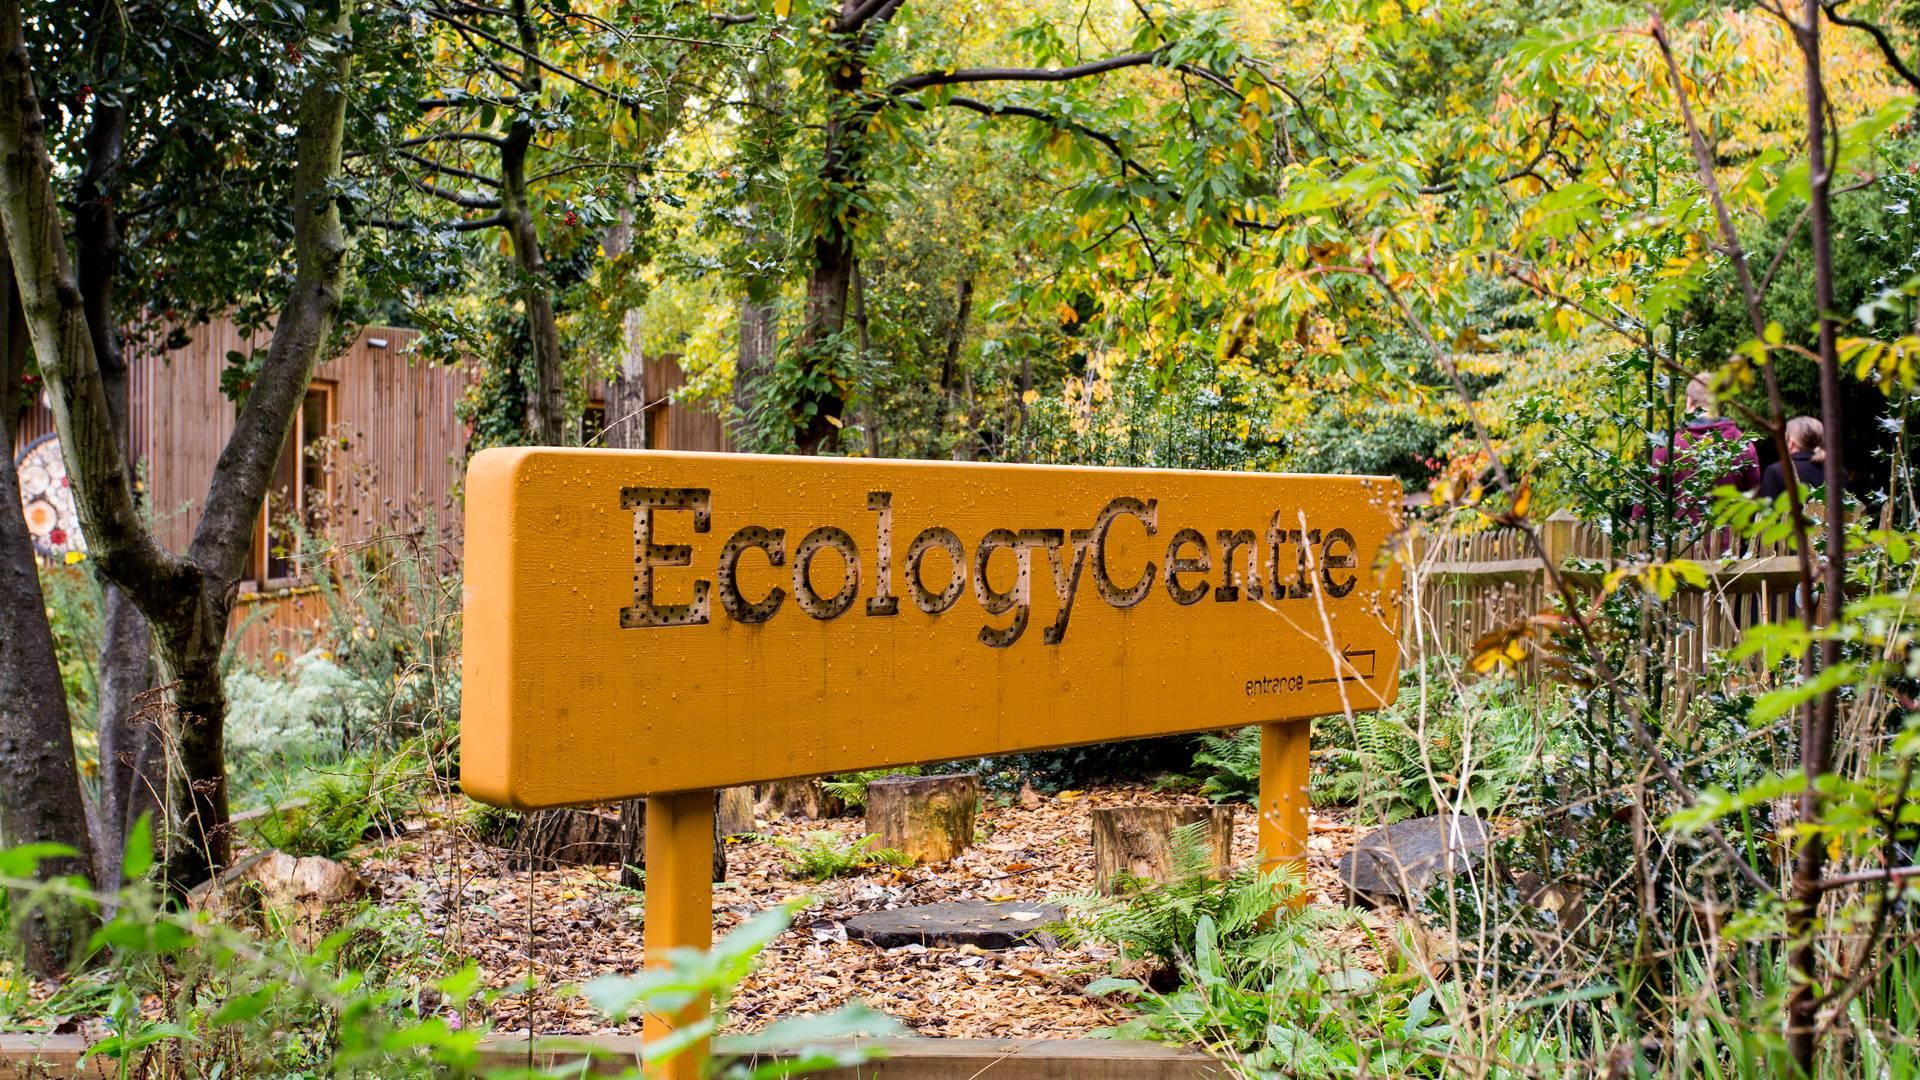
359;788;1384;1038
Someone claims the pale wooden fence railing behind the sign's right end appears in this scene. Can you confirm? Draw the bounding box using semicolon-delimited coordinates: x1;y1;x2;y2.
1402;513;1799;680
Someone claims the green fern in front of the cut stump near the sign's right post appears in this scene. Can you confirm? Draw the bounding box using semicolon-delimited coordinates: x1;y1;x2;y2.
1056;821;1306;982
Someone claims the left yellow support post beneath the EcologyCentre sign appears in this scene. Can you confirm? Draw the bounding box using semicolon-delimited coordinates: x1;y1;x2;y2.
641;780;714;1080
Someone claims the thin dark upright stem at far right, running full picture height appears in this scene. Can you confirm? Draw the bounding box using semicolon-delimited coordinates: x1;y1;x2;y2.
1786;0;1847;1076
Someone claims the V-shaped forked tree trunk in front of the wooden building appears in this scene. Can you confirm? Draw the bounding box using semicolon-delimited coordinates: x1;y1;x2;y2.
0;0;351;892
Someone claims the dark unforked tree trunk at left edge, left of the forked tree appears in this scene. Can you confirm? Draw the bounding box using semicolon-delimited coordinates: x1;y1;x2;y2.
0;233;94;974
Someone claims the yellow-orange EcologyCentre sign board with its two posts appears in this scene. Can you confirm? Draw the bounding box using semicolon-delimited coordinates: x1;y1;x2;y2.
461;450;1400;1068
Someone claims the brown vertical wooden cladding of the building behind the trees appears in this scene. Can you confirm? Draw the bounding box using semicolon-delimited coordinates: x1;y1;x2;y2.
12;319;728;661
